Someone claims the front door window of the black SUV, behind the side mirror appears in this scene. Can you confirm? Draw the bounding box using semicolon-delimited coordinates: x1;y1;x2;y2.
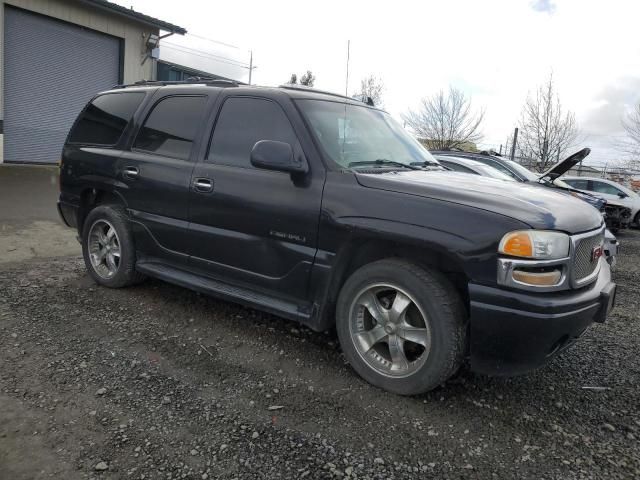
206;97;298;168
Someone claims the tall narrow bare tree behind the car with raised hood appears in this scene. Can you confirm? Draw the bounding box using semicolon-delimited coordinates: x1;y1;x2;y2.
518;75;578;172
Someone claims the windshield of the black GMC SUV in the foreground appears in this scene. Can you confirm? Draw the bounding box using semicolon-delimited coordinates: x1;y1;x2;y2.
297;100;438;168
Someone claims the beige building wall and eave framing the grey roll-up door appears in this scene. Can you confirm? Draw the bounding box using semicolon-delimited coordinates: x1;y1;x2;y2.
0;0;158;163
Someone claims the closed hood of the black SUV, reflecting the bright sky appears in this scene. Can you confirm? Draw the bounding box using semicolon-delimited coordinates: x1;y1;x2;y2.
356;170;602;234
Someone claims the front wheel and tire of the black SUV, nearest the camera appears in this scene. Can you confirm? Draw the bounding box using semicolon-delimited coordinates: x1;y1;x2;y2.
336;259;467;395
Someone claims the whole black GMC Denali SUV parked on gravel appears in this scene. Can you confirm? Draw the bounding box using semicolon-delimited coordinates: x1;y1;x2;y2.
58;82;615;394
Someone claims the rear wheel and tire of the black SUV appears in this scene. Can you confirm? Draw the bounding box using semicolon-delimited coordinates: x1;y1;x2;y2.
82;205;145;288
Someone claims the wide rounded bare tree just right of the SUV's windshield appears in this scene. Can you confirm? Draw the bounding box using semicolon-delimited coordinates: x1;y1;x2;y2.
402;86;484;150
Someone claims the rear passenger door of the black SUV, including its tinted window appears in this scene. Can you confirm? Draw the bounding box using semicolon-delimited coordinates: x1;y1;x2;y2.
117;89;210;263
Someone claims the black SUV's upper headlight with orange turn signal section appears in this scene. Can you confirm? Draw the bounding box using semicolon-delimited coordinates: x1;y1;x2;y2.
498;230;570;260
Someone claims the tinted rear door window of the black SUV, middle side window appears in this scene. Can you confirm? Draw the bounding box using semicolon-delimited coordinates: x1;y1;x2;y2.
133;96;207;160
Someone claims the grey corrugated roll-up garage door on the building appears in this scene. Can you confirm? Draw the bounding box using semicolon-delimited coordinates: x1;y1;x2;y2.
4;7;120;163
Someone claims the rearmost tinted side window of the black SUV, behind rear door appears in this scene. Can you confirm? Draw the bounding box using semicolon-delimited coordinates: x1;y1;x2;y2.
69;92;144;146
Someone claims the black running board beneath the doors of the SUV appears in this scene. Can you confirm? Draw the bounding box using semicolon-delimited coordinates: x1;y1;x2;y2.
136;261;311;324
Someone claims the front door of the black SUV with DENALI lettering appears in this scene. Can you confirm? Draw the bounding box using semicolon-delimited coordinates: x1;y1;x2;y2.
189;93;325;300
